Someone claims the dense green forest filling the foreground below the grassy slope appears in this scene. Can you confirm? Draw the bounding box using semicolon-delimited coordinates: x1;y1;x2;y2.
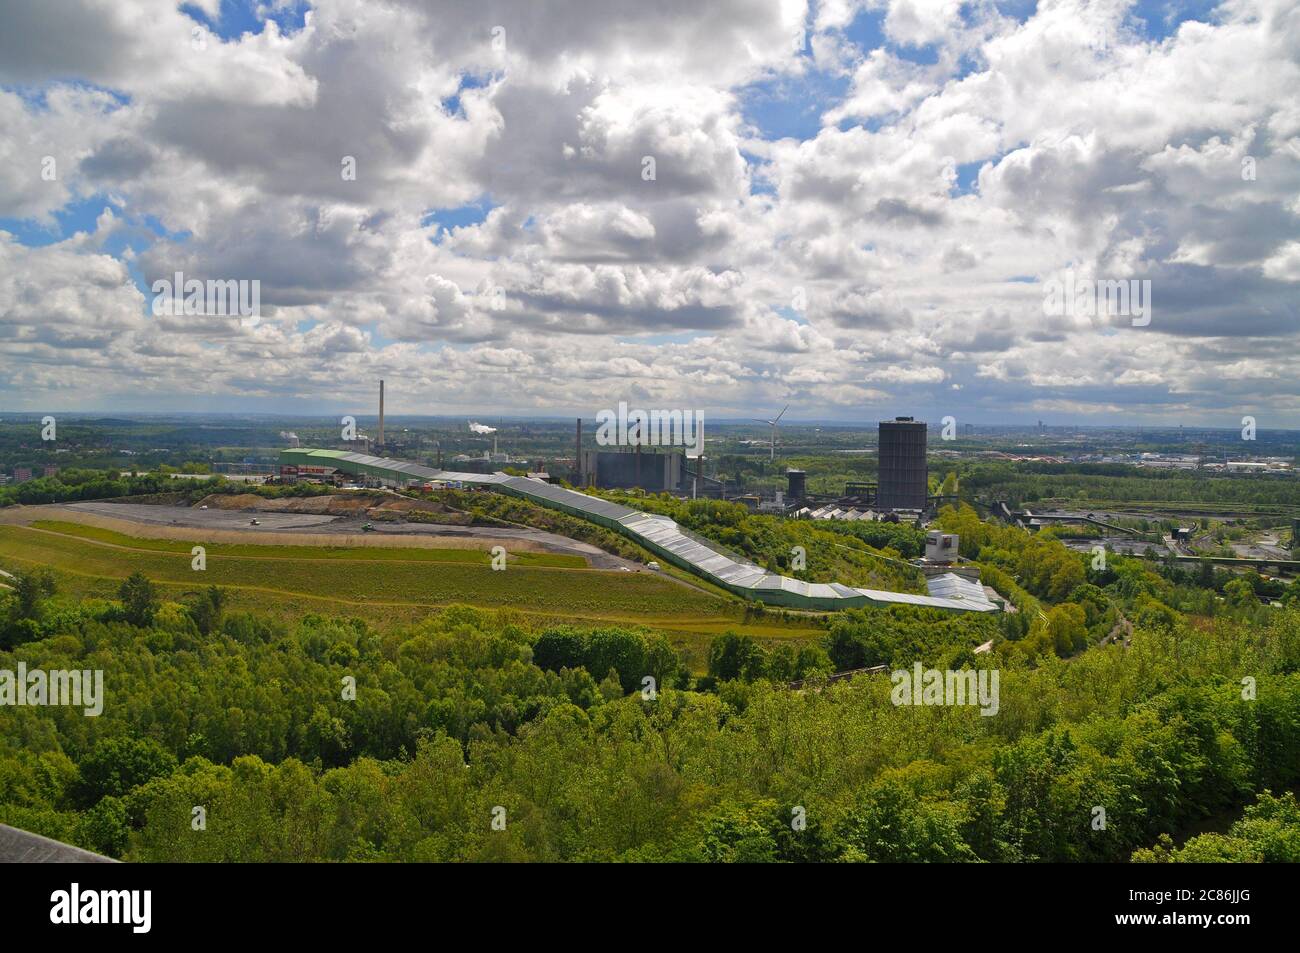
0;527;1300;862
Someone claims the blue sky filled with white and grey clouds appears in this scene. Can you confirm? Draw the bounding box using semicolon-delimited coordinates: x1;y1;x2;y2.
0;0;1300;428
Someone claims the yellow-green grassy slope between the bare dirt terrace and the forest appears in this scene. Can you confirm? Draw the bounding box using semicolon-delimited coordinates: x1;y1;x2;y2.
0;524;823;671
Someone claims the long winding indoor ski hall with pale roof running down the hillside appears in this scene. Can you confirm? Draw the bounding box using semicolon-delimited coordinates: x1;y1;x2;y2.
280;449;997;612
